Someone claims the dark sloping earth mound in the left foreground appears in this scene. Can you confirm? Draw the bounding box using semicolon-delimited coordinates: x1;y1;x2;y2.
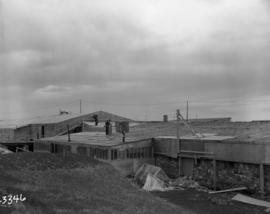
0;153;191;214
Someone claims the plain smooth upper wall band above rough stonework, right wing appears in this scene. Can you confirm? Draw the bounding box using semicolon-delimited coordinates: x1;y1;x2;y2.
154;137;270;163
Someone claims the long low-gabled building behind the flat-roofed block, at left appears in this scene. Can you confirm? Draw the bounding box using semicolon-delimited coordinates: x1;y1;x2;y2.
0;111;131;142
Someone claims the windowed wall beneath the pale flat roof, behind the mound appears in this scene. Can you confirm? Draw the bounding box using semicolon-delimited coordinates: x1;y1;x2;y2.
34;139;154;176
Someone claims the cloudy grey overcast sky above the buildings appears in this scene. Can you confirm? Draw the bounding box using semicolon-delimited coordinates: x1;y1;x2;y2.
0;0;270;120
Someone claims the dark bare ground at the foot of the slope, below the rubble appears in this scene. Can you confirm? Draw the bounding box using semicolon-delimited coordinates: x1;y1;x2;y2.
152;189;266;214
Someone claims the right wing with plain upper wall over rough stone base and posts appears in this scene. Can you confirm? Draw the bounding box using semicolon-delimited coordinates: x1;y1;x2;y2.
154;135;270;192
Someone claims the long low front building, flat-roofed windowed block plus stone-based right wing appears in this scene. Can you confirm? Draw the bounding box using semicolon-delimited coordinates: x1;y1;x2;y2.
31;129;270;192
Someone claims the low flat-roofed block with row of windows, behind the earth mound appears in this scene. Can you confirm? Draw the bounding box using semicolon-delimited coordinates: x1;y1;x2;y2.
34;132;154;175
